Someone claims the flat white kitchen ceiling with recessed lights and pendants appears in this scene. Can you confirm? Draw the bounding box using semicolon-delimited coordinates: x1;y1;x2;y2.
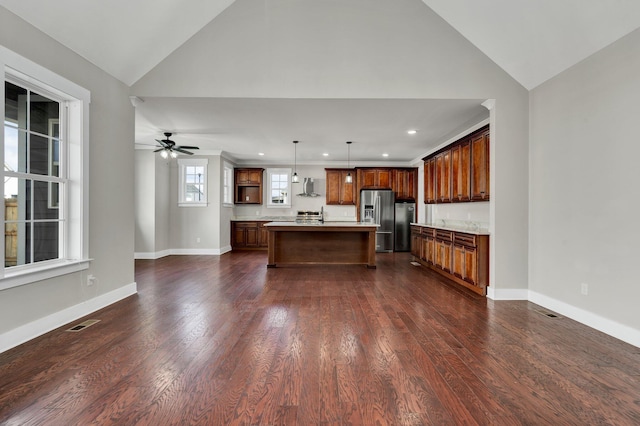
136;98;489;165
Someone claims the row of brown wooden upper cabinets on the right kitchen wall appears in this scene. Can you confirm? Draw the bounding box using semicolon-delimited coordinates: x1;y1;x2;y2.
423;126;490;204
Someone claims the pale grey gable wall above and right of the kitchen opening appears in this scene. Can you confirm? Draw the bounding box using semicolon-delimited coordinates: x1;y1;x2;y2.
132;0;529;294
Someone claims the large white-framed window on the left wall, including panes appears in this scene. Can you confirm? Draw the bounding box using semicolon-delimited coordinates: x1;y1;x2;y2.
0;46;90;290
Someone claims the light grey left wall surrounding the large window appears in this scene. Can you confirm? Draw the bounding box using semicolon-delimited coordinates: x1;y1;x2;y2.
0;7;135;350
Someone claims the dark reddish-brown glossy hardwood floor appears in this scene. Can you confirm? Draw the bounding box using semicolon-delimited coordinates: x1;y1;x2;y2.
0;252;640;425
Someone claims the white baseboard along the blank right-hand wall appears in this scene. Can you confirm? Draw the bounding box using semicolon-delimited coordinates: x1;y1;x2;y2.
528;291;640;348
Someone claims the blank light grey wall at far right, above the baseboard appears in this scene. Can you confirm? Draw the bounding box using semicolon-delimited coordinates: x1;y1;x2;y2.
529;25;640;340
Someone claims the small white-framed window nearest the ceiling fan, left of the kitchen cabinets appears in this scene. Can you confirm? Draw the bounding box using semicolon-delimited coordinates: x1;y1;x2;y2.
178;158;209;207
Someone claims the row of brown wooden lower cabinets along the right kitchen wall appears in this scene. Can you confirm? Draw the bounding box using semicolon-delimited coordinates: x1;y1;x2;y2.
411;225;489;295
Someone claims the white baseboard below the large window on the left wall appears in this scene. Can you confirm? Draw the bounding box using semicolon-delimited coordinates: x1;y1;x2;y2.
0;282;138;353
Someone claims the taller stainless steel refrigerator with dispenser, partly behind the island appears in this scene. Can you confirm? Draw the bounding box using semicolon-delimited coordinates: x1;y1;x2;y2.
360;189;395;252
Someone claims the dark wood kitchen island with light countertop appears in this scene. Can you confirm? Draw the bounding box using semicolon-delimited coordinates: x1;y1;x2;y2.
264;222;378;268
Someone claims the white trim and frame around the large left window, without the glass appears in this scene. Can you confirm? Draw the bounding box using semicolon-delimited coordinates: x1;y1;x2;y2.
0;46;91;290
